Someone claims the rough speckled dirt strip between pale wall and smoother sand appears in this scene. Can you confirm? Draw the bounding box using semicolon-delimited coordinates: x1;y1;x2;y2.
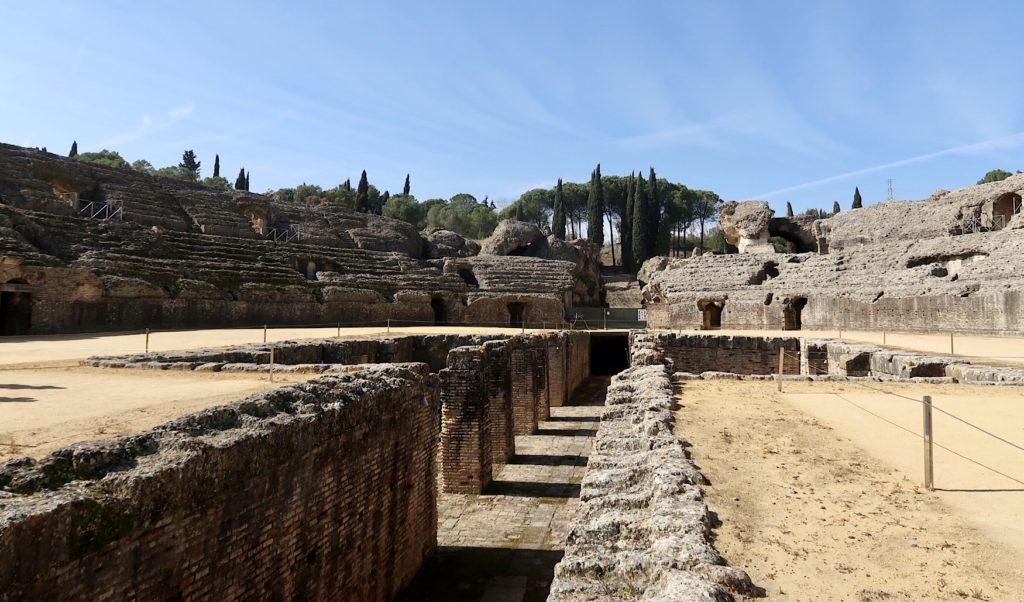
677;381;1024;601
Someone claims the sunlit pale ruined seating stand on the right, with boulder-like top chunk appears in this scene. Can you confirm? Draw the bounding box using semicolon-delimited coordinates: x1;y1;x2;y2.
639;174;1024;333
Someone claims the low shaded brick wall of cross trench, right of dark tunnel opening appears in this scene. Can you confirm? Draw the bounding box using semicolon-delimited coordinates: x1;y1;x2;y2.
654;334;800;374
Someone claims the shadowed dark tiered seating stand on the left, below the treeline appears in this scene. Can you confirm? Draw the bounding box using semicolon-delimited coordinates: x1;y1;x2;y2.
0;144;601;335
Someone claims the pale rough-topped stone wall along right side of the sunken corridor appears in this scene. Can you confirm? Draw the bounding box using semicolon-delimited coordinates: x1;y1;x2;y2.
548;354;756;602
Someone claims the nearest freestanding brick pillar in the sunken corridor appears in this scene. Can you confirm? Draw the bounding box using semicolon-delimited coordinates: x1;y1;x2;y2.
437;347;492;493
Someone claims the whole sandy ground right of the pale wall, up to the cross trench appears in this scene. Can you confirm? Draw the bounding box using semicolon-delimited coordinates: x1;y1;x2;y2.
677;381;1024;601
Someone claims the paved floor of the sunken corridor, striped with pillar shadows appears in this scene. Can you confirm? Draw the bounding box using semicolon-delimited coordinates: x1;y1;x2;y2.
399;377;610;602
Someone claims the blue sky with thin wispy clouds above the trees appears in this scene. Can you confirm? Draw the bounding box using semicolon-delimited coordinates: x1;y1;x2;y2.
6;1;1024;211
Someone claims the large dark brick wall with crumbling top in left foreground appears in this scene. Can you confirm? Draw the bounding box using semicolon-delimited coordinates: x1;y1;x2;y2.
0;364;439;600
